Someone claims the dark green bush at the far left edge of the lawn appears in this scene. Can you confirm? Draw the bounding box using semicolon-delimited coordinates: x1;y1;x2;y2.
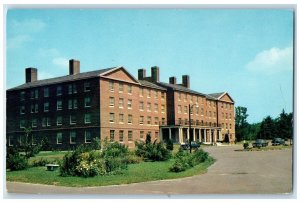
6;148;28;171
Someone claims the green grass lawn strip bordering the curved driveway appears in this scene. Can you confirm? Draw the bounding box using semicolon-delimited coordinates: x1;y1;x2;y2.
6;157;214;187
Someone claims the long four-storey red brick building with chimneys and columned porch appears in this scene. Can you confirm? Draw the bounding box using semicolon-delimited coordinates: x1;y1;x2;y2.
6;59;235;149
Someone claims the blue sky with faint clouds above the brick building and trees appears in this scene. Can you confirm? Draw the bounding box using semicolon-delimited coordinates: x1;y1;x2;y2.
6;9;293;123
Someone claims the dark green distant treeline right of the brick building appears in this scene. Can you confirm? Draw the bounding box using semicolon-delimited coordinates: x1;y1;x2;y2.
235;106;293;141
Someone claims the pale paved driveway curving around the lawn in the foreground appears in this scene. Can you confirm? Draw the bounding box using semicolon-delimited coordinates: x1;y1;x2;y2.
7;146;292;197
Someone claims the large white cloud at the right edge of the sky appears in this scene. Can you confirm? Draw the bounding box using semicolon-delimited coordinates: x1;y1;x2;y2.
246;47;293;74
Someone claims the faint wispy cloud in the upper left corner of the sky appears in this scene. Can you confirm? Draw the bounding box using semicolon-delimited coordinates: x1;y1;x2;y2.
11;19;46;34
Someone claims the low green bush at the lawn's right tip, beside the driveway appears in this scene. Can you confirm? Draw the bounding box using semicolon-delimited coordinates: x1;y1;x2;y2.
169;149;208;173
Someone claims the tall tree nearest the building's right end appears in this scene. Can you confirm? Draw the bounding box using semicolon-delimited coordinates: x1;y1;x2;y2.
235;106;249;141
